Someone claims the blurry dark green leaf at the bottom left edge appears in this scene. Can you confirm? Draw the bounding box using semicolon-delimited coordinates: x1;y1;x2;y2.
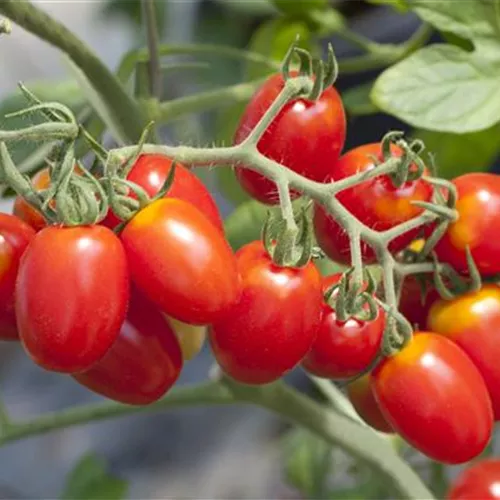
61;454;128;500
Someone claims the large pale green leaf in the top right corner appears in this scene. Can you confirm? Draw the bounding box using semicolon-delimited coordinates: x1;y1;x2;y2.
371;0;500;133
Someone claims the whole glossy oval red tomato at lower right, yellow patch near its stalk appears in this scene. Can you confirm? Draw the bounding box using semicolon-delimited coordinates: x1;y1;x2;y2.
371;332;493;464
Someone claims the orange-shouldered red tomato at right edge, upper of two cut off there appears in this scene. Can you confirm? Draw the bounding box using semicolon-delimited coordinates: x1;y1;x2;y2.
435;173;500;276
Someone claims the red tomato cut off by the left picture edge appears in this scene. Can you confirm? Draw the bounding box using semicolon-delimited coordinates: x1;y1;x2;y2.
0;213;35;340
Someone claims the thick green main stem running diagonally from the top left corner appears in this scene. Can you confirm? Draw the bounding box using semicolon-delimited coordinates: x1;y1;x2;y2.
0;0;146;142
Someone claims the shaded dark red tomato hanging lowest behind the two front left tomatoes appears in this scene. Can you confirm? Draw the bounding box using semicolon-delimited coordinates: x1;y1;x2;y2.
73;289;182;405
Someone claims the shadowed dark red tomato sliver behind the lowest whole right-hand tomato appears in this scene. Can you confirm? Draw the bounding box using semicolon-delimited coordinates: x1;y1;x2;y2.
347;374;394;433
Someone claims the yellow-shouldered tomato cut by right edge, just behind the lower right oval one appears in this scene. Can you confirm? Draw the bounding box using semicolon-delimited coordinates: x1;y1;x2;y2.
427;284;500;420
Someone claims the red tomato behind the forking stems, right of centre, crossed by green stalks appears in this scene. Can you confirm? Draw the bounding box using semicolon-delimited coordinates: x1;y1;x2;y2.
314;143;433;264
